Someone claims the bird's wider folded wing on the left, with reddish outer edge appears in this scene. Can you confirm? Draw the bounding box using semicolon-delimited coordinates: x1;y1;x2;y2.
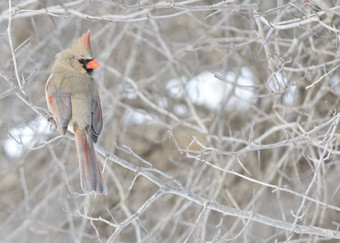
45;74;72;134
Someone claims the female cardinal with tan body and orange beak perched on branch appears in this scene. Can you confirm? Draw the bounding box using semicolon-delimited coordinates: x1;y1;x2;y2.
45;31;107;194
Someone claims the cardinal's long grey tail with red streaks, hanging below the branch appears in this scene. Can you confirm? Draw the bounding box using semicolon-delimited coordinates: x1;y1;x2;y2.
74;128;107;195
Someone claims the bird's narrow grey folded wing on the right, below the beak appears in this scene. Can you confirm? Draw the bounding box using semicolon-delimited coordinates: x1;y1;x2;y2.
91;96;103;143
